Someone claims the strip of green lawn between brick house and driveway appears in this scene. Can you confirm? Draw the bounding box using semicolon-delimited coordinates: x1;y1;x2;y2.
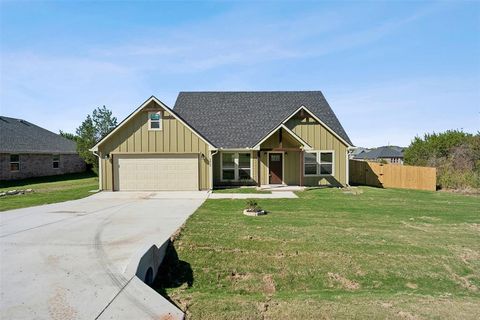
0;172;98;211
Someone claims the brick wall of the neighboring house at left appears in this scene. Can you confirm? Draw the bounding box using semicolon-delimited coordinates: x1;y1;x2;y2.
0;153;86;180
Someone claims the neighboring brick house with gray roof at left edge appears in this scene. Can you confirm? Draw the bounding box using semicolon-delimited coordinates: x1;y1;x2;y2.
0;116;86;180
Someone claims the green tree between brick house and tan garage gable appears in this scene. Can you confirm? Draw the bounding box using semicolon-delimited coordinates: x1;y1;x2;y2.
76;106;117;173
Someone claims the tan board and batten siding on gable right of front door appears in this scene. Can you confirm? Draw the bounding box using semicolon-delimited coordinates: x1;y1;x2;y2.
286;117;348;186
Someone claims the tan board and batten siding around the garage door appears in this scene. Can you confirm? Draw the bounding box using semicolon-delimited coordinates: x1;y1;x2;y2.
98;101;211;190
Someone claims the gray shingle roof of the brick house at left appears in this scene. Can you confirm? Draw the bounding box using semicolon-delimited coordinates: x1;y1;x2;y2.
0;116;76;153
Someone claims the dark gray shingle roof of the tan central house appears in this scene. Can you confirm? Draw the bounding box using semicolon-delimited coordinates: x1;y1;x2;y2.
173;91;353;148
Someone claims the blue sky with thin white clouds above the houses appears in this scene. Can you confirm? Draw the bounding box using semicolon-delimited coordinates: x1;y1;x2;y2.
0;1;480;146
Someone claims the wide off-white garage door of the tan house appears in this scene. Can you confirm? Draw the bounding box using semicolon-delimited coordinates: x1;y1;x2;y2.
114;154;198;191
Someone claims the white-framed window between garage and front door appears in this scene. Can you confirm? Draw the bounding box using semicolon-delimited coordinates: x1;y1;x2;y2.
220;152;252;181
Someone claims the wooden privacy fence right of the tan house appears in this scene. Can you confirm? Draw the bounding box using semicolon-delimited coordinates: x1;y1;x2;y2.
349;160;437;191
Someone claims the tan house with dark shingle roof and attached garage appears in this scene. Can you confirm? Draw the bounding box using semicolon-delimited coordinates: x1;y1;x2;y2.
91;91;353;190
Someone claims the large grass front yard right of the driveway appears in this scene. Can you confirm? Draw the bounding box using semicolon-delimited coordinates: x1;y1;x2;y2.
154;187;480;319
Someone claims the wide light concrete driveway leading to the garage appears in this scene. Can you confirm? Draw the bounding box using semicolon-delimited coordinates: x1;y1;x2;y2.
0;192;207;319
